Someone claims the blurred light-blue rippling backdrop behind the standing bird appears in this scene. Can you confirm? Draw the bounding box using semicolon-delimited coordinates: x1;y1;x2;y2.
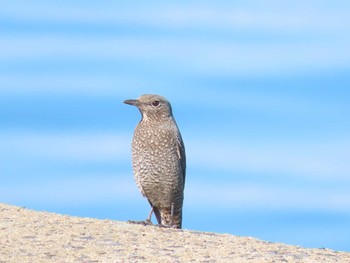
0;0;350;254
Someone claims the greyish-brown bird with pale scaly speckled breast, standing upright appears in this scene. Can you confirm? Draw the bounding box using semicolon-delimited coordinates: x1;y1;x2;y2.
124;94;186;229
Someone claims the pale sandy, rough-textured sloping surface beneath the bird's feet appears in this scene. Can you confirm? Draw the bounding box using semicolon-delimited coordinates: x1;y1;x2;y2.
0;204;350;263
